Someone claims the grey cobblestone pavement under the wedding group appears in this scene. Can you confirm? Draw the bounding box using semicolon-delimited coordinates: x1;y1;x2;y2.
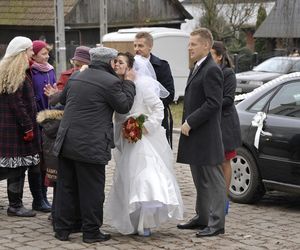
0;132;300;250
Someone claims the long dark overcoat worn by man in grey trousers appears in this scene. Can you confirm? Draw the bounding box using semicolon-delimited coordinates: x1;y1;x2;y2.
177;54;224;166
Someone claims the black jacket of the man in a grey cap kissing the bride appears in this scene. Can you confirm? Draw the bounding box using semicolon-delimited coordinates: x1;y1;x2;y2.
54;63;135;164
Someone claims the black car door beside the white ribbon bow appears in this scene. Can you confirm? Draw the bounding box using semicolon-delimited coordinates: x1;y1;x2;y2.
258;80;300;185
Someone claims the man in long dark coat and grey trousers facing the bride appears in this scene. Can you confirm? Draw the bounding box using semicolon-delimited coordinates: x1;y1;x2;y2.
177;28;226;237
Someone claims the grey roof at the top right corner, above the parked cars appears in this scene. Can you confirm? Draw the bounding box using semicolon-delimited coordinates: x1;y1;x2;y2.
254;0;300;38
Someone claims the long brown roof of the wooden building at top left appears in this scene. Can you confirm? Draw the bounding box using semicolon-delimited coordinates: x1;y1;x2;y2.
0;0;193;27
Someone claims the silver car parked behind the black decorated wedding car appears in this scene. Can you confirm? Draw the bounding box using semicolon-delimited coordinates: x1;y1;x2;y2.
235;56;300;94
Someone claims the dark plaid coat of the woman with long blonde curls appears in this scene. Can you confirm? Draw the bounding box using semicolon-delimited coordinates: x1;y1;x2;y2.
0;71;41;157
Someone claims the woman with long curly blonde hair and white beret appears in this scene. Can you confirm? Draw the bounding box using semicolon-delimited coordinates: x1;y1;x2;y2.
0;36;41;217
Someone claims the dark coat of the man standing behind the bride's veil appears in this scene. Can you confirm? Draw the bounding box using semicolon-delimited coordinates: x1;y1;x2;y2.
150;54;175;146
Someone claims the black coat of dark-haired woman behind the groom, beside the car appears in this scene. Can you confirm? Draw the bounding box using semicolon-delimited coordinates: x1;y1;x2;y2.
221;67;242;151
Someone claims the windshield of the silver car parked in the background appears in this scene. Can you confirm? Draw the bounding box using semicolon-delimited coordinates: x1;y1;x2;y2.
253;58;295;74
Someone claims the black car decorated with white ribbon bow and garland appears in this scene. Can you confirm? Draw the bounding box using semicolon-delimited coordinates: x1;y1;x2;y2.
229;73;300;203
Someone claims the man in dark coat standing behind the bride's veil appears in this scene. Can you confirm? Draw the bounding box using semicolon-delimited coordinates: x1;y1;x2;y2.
133;32;175;147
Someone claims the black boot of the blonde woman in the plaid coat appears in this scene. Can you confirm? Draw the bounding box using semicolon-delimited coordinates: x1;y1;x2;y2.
7;173;36;217
